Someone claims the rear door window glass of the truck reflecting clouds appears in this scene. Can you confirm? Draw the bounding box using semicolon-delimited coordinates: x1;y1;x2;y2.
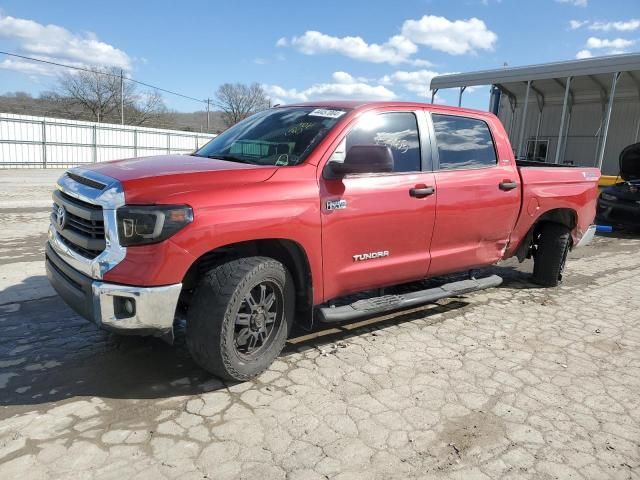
431;114;497;170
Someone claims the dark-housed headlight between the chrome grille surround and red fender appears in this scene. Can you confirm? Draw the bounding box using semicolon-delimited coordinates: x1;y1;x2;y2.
117;205;193;247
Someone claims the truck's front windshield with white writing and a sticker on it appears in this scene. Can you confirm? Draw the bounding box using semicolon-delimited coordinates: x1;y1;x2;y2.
194;107;346;166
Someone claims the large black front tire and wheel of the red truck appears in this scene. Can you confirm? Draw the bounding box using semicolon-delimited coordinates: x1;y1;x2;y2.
187;257;295;381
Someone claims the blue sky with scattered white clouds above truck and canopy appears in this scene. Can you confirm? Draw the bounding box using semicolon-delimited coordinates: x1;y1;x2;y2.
0;0;640;111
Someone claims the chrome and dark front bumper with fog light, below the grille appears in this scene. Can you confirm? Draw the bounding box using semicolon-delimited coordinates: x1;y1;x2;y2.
45;243;182;337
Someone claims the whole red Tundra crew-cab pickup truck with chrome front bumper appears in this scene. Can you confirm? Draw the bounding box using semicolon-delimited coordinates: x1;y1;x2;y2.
46;102;600;380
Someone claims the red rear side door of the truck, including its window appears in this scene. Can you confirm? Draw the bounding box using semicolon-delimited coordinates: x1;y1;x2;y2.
428;113;521;276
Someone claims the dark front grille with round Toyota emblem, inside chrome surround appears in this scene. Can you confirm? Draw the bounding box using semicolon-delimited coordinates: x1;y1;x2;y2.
51;190;106;259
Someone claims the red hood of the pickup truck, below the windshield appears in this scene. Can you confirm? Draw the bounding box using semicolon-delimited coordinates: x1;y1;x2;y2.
77;155;277;204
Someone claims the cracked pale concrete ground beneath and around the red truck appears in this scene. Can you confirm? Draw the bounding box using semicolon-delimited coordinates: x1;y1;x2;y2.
0;171;640;480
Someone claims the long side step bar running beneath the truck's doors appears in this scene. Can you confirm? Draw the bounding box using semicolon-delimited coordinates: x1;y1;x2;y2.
317;275;502;323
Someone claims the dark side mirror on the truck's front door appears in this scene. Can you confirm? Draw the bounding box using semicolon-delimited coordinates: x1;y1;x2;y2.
326;145;393;178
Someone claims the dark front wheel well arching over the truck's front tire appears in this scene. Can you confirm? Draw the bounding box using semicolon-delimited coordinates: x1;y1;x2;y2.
182;239;313;318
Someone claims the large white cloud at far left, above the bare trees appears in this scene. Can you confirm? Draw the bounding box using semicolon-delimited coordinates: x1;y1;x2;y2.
0;14;131;74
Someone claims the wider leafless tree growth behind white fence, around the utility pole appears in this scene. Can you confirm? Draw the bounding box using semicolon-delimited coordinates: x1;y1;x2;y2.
53;67;167;125
